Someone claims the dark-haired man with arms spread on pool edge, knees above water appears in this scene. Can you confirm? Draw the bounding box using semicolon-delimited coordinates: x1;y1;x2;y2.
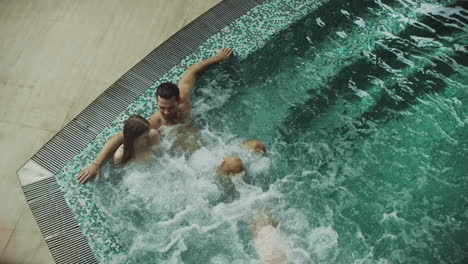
77;48;266;183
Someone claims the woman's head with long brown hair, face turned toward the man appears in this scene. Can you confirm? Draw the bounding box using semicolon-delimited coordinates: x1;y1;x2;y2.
122;115;151;164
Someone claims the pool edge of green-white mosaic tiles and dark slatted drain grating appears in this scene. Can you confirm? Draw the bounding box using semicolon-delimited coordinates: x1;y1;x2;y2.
17;0;319;263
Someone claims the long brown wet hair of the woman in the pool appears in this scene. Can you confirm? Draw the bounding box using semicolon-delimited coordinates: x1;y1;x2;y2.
121;115;150;164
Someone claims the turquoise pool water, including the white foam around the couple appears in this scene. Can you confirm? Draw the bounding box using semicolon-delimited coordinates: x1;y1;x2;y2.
94;1;468;263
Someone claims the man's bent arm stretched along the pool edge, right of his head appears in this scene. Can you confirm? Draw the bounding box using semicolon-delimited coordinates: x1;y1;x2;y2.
177;48;232;102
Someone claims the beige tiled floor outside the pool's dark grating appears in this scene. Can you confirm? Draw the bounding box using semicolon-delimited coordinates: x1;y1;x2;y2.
0;0;220;264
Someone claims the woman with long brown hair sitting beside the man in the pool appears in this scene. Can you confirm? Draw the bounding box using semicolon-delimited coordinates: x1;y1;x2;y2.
113;115;161;166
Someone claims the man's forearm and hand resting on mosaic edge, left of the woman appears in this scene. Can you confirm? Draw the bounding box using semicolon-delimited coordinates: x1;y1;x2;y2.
76;132;123;183
